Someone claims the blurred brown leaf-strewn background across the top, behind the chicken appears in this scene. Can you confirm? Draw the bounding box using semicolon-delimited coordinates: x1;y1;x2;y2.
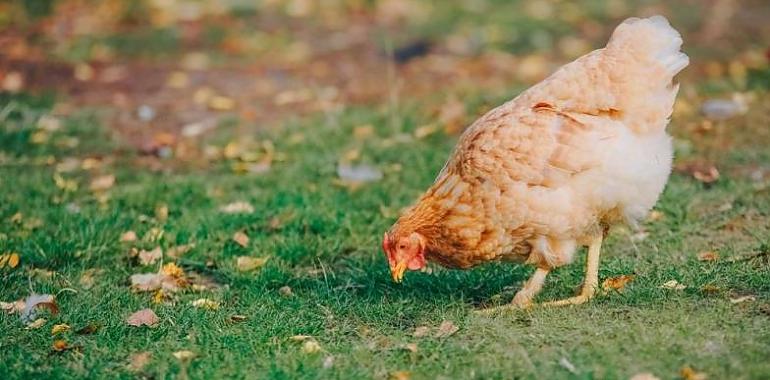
0;0;770;166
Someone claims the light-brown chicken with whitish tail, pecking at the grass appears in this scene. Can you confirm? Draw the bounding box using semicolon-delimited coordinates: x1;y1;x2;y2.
382;16;689;307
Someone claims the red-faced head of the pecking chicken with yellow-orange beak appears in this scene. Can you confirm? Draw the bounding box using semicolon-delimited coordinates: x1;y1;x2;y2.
382;232;425;282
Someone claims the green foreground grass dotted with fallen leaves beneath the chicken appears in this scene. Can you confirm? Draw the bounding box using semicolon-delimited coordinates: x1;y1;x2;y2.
0;87;770;378
